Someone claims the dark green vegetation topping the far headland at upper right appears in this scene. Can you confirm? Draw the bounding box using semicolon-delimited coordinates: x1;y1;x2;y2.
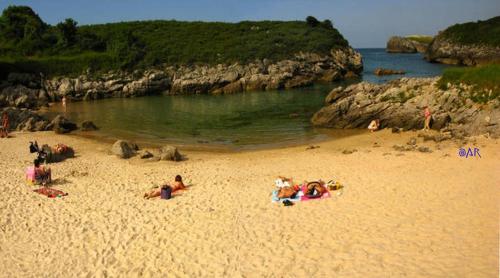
440;16;500;47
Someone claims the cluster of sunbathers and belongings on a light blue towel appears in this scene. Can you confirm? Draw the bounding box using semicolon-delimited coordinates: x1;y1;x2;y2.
271;176;344;206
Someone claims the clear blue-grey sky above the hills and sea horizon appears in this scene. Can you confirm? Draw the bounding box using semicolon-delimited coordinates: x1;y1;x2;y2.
0;0;500;48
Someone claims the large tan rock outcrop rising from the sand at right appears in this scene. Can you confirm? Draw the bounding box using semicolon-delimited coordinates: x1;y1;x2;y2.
312;78;500;136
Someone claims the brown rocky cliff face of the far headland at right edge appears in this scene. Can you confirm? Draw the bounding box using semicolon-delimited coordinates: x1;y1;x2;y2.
425;35;500;66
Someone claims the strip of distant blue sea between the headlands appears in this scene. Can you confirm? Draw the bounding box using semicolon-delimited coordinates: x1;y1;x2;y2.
356;48;449;84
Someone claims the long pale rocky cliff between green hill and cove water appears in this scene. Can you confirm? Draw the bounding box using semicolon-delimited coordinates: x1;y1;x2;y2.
0;48;363;108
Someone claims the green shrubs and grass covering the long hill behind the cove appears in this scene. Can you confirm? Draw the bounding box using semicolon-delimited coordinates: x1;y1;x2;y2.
0;6;348;75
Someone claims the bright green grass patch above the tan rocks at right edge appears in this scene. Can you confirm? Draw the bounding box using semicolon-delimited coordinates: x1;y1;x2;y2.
438;64;500;103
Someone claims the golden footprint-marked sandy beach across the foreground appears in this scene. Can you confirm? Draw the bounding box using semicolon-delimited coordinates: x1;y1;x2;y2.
0;130;500;277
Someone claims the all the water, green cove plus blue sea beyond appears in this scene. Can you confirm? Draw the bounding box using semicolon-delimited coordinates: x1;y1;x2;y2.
48;49;452;149
